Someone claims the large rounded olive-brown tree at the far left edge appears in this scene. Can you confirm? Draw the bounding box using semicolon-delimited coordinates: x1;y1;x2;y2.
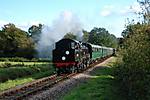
0;23;34;58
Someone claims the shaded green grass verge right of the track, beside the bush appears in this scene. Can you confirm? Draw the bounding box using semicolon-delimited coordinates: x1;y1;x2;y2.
62;58;123;100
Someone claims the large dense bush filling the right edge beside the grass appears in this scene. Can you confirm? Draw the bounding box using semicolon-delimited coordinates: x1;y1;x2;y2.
114;24;150;100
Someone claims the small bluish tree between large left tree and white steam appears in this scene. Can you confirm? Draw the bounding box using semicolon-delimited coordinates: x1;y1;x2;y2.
28;24;43;43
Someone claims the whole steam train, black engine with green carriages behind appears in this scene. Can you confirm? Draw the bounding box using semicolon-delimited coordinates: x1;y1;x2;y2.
52;39;115;74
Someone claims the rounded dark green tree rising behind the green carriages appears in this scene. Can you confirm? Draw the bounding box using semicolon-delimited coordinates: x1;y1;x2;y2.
88;27;117;48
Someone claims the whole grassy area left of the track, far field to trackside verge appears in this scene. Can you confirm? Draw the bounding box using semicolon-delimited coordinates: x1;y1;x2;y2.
0;58;54;91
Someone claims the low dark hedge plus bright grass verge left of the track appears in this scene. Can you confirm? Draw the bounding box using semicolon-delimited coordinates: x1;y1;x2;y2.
0;62;54;91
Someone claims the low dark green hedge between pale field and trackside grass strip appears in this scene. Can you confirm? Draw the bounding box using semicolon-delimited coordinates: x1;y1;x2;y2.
0;64;53;82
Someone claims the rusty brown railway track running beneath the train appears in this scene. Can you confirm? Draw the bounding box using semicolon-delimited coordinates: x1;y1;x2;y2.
0;58;109;100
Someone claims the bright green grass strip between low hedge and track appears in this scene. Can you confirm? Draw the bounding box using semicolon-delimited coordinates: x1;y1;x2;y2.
0;70;53;91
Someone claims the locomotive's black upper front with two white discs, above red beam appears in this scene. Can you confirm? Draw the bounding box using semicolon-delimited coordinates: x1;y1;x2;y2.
53;39;81;65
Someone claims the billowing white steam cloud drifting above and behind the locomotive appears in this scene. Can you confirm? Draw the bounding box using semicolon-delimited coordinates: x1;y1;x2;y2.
36;11;83;58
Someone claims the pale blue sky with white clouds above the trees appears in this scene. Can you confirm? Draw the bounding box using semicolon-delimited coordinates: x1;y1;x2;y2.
0;0;141;37
